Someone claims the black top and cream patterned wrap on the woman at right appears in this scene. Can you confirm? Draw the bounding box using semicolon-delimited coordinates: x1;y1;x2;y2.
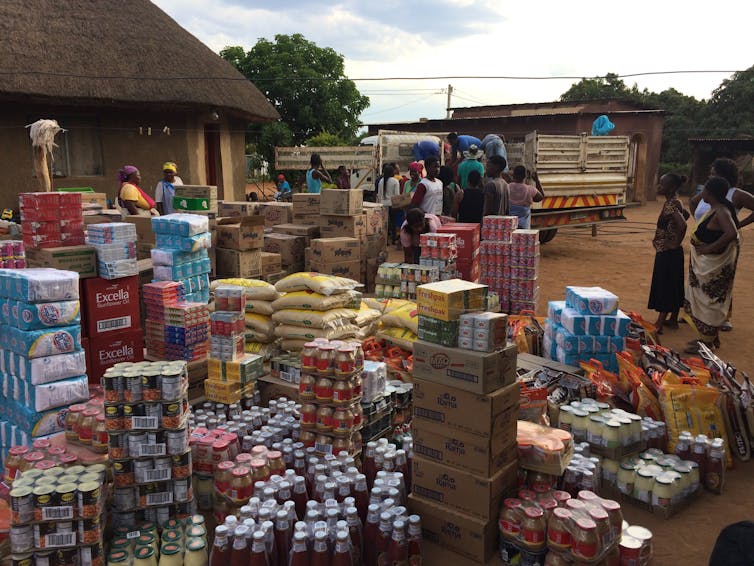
684;211;739;343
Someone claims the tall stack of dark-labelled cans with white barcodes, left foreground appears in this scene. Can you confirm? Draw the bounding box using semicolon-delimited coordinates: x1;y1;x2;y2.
102;362;194;527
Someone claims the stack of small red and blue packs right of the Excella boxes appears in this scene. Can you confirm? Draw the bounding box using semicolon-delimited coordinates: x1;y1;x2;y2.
142;281;210;362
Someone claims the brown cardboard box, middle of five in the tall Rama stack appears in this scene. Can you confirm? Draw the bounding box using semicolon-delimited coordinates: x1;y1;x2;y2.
411;418;518;477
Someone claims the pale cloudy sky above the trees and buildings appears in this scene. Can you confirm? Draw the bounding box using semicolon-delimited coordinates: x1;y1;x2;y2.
153;0;754;128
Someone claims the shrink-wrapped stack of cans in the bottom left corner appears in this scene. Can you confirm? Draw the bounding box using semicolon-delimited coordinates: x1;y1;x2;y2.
10;462;106;564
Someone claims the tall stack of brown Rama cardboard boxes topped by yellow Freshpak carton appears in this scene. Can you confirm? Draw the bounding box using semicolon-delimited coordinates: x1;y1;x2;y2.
409;279;519;562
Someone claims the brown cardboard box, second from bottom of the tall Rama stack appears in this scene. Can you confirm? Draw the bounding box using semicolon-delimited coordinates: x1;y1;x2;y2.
411;455;518;520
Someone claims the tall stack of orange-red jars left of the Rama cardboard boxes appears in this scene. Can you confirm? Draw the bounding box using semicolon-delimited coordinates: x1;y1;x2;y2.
299;340;364;454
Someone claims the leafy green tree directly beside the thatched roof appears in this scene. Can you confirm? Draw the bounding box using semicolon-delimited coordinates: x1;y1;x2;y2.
220;33;369;145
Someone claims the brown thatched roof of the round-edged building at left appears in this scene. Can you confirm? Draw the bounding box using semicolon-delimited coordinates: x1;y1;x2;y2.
0;0;278;120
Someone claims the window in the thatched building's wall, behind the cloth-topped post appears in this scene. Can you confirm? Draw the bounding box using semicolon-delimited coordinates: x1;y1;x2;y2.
32;118;104;179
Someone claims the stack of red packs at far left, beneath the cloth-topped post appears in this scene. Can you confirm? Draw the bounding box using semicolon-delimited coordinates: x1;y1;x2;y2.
18;193;84;249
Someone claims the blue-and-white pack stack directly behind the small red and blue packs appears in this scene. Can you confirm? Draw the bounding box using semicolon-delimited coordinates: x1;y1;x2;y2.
152;214;212;303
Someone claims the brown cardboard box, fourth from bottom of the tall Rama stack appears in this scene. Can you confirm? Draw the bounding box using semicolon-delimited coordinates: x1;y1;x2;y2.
413;378;520;444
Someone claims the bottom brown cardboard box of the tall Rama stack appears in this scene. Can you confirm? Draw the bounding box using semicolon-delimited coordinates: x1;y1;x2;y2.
408;494;498;564
